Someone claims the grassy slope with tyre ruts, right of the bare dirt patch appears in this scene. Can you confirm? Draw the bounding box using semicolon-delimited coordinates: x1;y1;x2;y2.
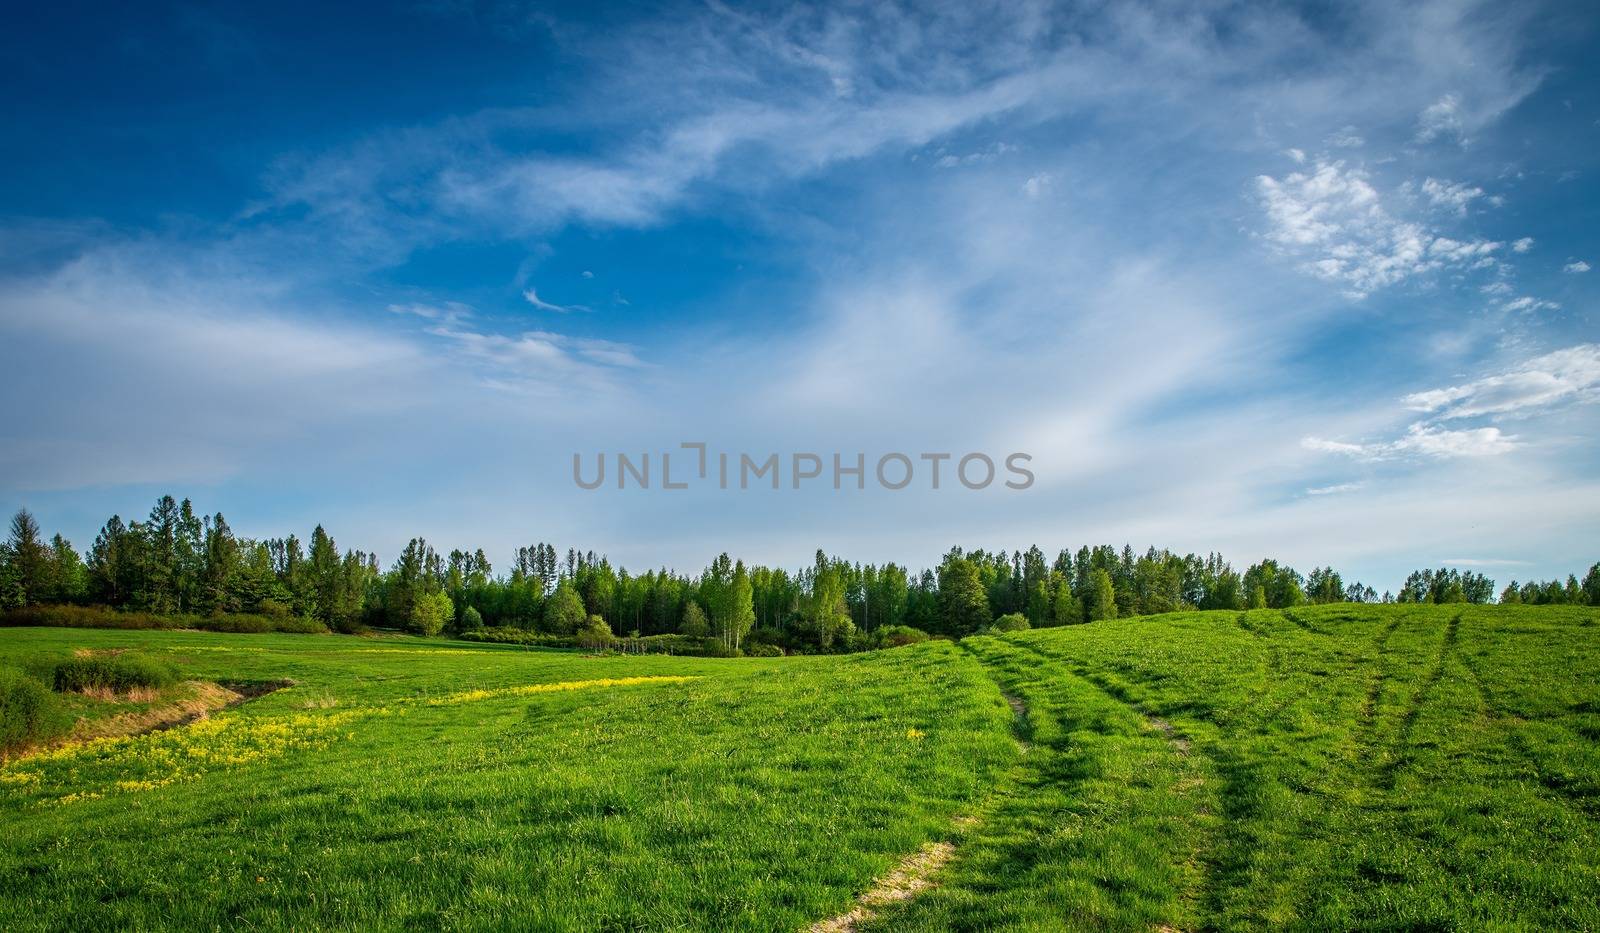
878;607;1600;930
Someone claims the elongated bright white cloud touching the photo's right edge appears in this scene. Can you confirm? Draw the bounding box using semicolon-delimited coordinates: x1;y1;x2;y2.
1400;344;1600;419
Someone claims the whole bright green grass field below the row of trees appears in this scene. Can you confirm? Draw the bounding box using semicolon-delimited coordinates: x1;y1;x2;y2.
0;605;1600;930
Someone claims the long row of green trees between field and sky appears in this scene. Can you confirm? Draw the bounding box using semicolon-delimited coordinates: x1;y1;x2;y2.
0;496;1600;653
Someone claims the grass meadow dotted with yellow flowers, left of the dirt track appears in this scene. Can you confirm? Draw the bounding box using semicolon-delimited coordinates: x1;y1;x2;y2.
0;629;1014;930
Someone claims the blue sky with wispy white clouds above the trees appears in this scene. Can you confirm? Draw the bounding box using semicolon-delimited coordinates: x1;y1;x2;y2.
0;2;1600;589
